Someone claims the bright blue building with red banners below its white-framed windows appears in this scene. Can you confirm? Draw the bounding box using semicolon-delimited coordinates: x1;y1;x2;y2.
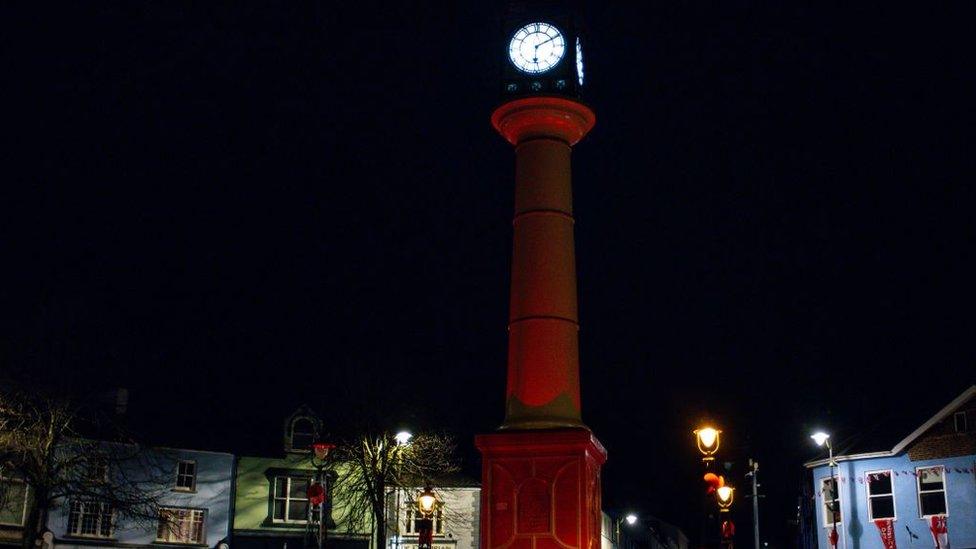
806;385;976;549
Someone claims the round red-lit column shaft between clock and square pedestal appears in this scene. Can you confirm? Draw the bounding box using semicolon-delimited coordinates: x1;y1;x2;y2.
492;97;596;429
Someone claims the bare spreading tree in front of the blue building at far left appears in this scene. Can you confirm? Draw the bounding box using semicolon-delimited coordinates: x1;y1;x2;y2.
0;388;170;549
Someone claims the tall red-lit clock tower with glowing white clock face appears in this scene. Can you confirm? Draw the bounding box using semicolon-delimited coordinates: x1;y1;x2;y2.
475;2;606;549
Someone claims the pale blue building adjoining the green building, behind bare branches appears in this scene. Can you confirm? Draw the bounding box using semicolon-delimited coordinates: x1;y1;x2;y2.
44;448;234;549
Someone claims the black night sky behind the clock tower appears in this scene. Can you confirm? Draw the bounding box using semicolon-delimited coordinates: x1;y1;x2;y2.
0;1;976;546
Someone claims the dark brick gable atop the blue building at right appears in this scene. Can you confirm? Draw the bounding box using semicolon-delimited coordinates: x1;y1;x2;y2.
906;397;976;461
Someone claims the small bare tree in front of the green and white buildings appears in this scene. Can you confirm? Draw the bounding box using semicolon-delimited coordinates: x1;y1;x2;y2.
330;432;459;549
